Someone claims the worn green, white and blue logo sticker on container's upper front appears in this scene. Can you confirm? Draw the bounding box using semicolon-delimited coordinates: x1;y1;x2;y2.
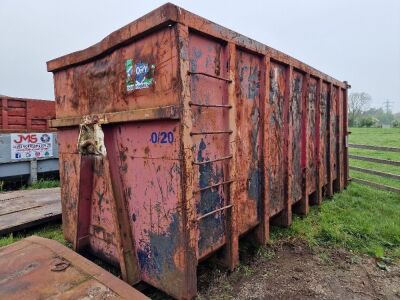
125;59;155;92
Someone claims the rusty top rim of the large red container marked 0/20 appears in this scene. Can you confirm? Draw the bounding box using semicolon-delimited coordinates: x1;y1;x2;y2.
47;3;348;89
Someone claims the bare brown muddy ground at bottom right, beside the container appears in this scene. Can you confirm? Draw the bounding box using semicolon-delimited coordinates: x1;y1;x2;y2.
145;240;400;300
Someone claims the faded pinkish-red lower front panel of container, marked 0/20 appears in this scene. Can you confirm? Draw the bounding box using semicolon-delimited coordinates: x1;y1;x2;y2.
105;121;185;291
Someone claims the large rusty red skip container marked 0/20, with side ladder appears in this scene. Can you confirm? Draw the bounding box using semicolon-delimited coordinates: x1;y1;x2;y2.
47;4;349;299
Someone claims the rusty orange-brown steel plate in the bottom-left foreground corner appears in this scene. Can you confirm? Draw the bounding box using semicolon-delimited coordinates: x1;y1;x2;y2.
0;236;148;300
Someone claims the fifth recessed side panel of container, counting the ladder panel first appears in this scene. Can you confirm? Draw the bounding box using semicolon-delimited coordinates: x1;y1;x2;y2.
307;77;318;194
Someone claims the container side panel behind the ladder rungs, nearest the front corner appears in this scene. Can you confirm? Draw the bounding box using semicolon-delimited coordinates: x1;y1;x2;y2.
189;33;231;258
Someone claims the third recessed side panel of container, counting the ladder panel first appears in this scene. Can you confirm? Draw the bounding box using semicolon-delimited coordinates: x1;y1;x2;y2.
264;63;287;216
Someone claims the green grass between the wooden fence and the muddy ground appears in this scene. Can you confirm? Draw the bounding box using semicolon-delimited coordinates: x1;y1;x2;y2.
272;183;400;260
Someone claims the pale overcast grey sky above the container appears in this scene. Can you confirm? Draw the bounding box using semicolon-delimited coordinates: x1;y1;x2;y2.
0;0;400;111
